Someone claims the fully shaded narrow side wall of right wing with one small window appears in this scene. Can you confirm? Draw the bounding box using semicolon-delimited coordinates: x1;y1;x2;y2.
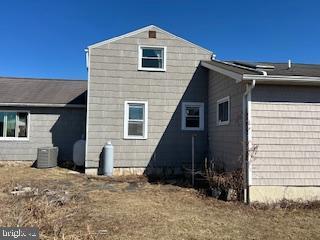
208;71;245;171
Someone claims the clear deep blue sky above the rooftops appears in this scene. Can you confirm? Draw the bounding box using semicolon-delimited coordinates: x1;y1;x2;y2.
0;0;320;79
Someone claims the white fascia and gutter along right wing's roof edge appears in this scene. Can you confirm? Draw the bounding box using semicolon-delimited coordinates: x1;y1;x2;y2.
242;74;320;85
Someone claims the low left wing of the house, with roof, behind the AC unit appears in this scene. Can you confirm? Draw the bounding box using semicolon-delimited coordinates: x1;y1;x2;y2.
0;77;87;161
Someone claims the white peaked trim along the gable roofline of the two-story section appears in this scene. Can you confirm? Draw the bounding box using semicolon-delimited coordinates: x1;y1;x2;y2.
88;25;212;54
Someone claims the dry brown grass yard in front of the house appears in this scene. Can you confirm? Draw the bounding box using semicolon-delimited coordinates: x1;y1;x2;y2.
0;166;320;240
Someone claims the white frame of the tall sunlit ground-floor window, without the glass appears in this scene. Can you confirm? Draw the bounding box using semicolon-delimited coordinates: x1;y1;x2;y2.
123;101;148;140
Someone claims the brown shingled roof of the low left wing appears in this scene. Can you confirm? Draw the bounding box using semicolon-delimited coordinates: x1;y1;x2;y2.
0;77;87;106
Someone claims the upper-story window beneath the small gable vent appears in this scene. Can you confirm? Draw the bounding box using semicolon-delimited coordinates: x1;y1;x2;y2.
138;46;166;71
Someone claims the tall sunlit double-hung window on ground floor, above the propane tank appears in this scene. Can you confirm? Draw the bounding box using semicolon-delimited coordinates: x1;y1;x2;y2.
124;101;148;139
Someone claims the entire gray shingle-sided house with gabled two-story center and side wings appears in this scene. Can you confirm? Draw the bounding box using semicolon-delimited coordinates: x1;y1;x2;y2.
0;25;320;201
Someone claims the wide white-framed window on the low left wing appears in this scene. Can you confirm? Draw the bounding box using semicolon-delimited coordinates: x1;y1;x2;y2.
0;111;29;140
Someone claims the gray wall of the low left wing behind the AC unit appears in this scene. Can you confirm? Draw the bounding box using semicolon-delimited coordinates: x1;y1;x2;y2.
0;107;86;161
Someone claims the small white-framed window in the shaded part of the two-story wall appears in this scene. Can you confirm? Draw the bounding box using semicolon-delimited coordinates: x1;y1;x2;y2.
181;102;204;130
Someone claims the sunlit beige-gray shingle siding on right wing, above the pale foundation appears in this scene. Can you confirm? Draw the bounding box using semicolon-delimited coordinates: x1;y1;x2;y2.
251;85;320;186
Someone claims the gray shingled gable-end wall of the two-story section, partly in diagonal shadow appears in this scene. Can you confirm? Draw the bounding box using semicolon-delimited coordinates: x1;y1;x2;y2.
86;26;211;173
